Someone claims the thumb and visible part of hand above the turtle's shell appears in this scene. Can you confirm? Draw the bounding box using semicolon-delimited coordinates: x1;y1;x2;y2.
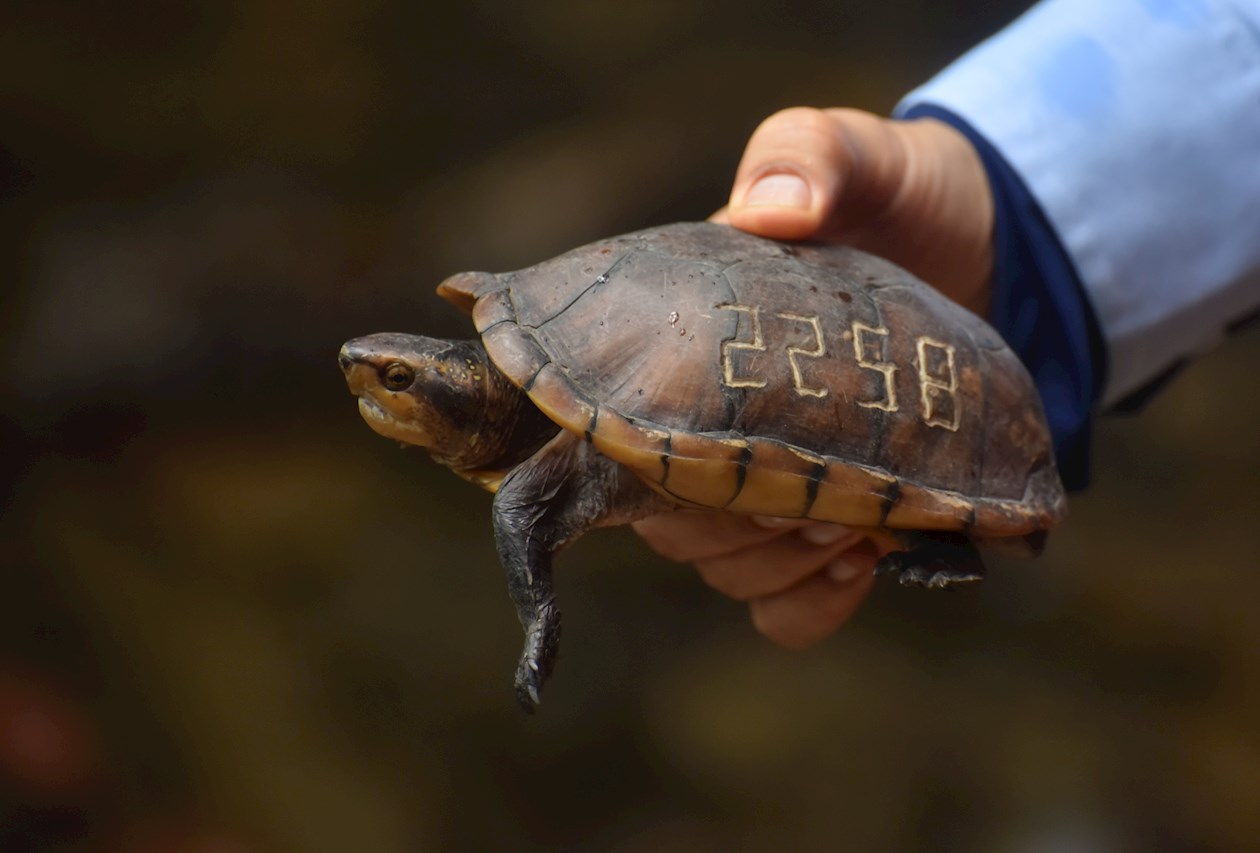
726;107;993;312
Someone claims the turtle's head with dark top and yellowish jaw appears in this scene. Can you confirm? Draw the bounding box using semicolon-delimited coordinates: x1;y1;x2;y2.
338;333;507;469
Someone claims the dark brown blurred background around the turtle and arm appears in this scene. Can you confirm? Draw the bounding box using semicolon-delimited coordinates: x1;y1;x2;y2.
0;0;1260;853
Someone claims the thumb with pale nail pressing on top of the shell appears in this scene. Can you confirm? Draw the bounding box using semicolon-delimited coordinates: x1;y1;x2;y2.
728;107;905;239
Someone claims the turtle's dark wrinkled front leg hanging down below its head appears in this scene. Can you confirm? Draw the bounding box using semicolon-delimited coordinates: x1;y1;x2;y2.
494;432;672;712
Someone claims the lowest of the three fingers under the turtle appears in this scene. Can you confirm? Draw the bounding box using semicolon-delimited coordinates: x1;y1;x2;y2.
748;547;877;649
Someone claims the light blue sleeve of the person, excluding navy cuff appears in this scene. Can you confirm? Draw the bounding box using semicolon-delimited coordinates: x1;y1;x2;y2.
898;0;1260;406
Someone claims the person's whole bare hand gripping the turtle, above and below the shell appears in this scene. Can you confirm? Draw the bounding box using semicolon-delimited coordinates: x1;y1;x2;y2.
634;107;993;649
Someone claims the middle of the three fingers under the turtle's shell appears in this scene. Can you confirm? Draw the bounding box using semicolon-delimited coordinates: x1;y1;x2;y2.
696;525;863;601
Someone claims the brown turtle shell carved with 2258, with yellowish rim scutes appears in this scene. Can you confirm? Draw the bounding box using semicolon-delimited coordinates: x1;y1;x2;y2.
438;223;1066;537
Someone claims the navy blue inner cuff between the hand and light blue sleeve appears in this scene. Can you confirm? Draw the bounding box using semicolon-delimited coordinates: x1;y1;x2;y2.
903;105;1106;490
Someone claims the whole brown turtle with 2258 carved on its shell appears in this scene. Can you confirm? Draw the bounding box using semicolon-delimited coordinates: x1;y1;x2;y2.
339;222;1066;711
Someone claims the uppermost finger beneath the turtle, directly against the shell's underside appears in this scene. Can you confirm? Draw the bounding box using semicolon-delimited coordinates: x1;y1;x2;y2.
634;509;811;563
